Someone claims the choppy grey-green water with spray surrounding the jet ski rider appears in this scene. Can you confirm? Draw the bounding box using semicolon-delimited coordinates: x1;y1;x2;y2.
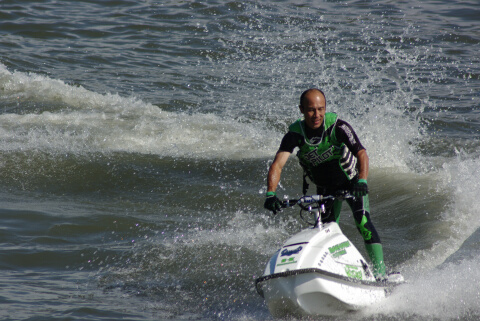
0;0;480;320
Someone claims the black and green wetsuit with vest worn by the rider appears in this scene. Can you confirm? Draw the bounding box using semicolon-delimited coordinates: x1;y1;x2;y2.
279;113;385;275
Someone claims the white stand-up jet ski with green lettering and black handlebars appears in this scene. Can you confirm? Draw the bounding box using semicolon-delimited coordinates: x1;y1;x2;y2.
255;191;403;318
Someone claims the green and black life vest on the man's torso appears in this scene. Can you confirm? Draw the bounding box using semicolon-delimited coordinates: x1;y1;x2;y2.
289;113;358;189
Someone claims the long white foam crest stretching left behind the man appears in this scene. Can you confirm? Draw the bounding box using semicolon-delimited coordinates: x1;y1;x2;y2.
0;65;279;159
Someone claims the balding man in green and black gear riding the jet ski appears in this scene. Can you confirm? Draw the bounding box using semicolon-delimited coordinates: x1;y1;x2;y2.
264;88;394;281
